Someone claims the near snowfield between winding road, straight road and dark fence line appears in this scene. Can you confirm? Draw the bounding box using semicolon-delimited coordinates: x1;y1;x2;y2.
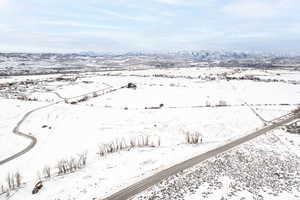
0;104;262;199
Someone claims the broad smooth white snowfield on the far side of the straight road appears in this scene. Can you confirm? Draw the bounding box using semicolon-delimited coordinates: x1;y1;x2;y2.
0;68;300;200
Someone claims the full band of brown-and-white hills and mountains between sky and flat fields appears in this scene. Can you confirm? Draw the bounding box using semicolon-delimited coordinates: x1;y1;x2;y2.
0;51;300;76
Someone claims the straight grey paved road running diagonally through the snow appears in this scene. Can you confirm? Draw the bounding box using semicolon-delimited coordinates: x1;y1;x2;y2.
103;113;300;200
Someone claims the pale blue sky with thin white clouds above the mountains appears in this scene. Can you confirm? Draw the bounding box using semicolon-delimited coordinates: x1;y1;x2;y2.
0;0;300;53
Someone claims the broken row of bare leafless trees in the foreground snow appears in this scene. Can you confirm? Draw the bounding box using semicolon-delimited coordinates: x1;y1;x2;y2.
0;131;202;195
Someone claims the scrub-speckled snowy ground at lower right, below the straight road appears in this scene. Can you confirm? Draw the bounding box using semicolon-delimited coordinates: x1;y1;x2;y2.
134;129;300;200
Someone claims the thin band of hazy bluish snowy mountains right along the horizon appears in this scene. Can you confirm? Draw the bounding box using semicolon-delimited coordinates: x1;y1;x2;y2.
0;50;299;61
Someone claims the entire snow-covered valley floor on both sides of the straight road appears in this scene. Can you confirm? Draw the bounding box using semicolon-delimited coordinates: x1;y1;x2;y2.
0;67;300;200
